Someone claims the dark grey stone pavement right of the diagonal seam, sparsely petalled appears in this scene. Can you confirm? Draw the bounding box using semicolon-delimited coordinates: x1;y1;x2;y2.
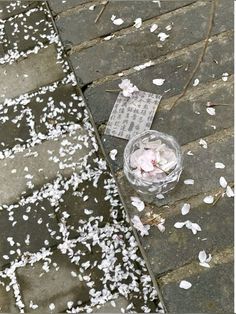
49;0;233;313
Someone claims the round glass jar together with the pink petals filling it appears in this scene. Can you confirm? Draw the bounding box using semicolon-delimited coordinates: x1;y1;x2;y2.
124;130;183;196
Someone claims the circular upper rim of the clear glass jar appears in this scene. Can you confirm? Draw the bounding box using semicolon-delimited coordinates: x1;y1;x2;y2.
124;130;183;185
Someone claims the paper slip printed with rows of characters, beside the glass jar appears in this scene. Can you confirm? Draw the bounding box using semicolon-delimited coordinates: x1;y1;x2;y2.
105;91;161;140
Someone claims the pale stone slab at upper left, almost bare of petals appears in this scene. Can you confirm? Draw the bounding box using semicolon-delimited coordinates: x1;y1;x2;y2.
0;45;64;102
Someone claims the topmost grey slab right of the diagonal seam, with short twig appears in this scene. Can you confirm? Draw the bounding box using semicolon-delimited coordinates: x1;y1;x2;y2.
55;0;194;46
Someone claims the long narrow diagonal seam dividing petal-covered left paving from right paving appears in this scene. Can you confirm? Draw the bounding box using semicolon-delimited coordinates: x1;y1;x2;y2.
45;1;167;312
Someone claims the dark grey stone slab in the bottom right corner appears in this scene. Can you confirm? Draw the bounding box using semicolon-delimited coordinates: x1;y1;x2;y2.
161;262;234;313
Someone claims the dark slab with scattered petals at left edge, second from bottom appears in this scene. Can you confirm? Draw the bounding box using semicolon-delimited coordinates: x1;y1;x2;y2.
0;199;59;268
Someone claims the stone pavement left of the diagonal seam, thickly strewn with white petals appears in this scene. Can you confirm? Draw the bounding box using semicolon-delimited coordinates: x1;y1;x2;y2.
0;1;163;313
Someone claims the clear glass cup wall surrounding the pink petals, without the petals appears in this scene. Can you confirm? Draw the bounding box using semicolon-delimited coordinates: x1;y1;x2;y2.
124;130;183;196
